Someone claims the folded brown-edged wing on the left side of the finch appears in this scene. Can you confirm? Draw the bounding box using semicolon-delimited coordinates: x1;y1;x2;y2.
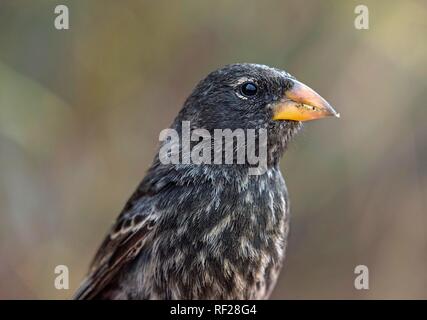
74;185;160;300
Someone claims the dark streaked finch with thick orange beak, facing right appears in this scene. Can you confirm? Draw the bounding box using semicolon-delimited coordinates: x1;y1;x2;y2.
74;63;339;300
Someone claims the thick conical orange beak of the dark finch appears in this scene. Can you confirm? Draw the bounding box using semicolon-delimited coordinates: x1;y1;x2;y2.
273;79;340;121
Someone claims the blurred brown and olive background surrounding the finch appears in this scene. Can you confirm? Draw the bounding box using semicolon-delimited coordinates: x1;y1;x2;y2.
0;0;427;299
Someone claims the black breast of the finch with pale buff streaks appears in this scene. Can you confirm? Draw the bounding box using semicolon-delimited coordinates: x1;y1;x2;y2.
151;169;288;299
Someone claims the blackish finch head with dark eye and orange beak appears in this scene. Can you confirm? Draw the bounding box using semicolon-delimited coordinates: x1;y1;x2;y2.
169;63;339;171
